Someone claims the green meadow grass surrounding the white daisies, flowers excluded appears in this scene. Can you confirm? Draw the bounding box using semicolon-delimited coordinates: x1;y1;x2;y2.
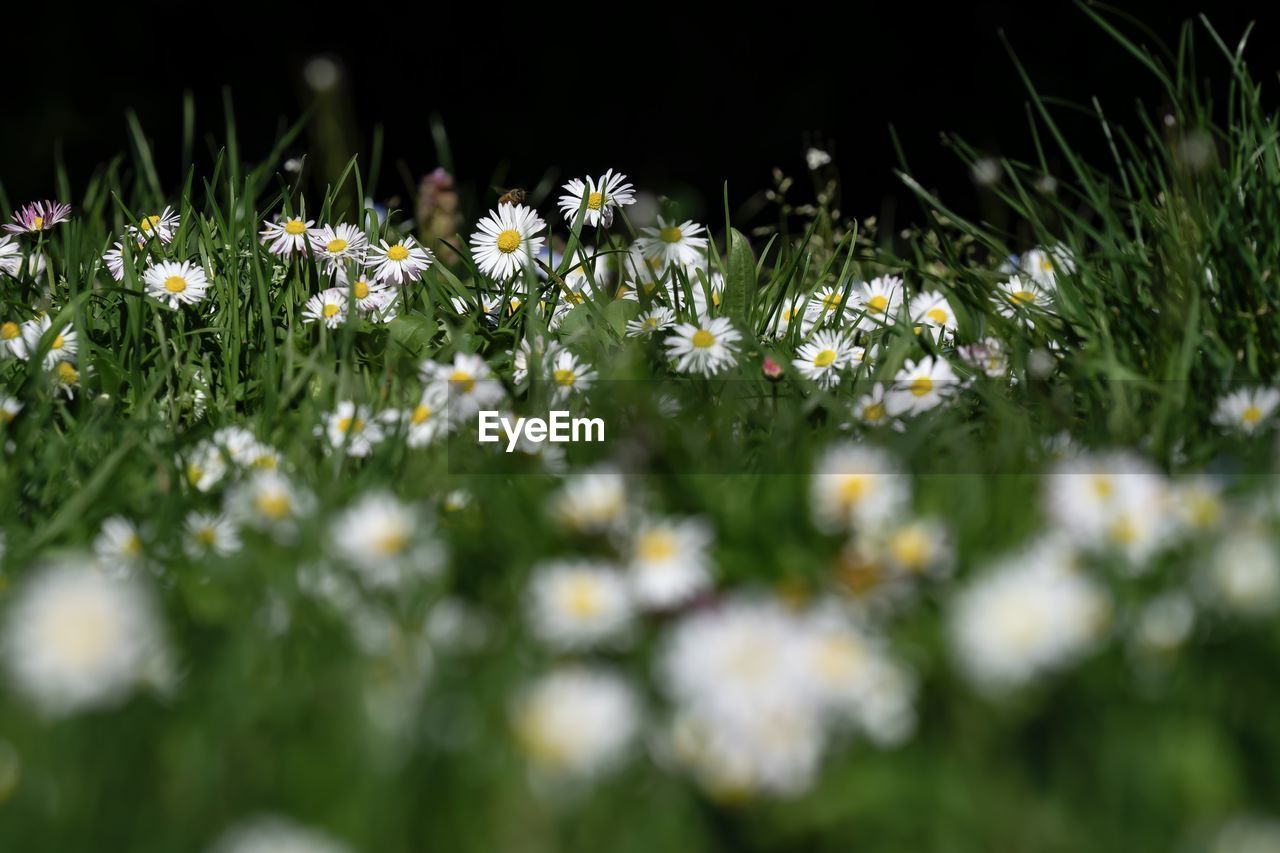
0;6;1280;853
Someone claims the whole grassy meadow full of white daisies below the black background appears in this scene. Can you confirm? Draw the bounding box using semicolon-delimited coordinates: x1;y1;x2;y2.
0;18;1280;853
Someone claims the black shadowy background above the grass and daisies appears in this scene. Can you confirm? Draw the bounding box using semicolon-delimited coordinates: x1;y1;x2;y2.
0;0;1280;225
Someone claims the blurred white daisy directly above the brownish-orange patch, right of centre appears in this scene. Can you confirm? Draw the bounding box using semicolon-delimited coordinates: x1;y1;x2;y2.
810;443;911;532
